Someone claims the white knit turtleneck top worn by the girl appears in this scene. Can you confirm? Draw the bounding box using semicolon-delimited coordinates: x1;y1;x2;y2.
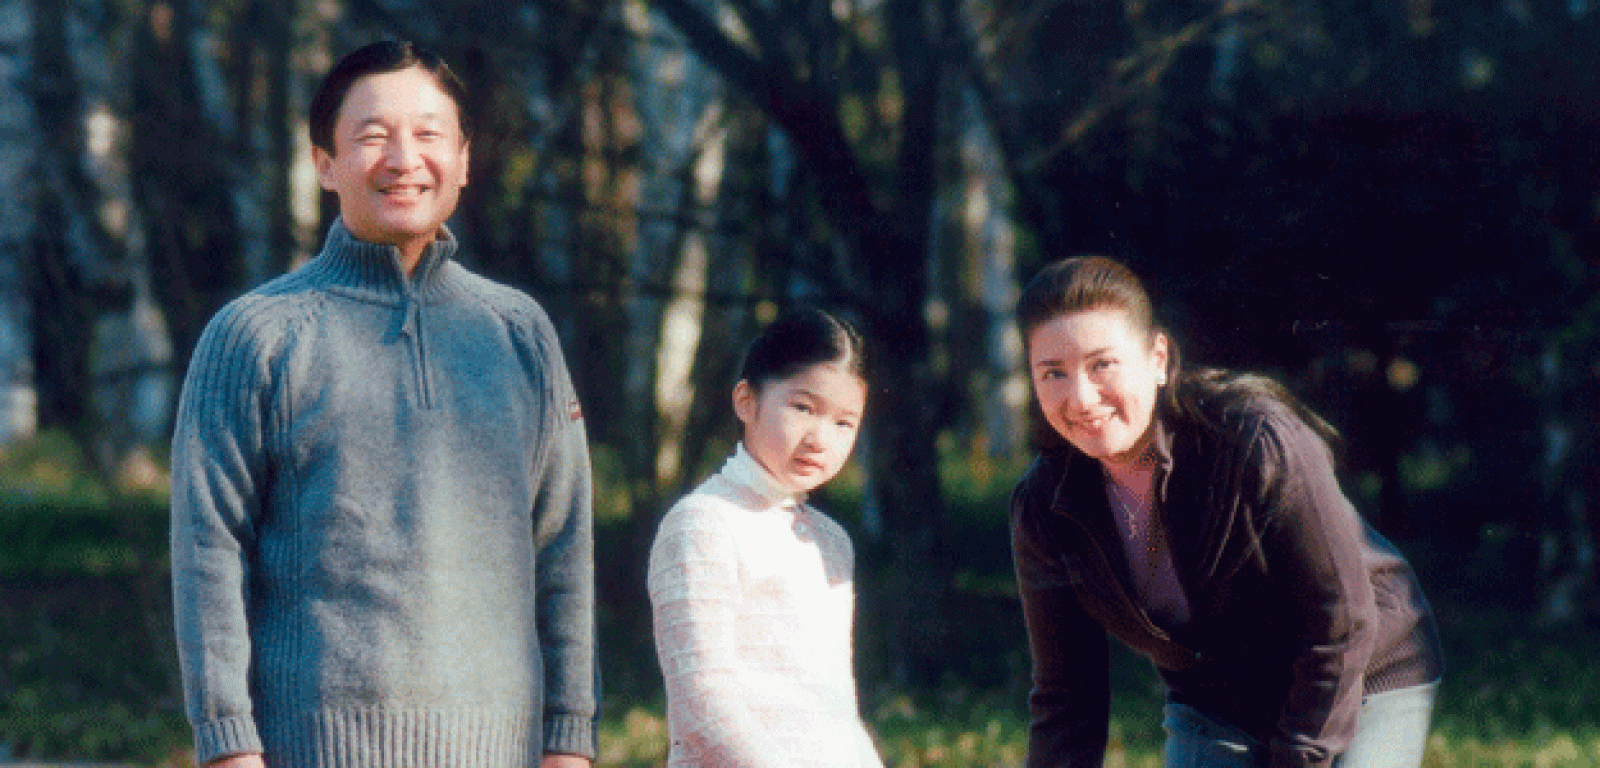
650;445;883;768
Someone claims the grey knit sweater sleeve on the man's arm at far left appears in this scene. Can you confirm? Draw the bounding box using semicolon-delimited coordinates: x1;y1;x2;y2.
171;304;267;765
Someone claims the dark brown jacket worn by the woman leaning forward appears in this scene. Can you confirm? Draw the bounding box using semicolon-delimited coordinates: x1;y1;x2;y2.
1011;398;1442;768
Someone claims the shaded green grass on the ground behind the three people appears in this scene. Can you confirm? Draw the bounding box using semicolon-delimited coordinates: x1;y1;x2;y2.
0;435;1600;768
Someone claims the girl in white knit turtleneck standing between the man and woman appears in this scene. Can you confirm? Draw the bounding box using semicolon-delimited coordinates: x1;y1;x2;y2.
650;309;882;768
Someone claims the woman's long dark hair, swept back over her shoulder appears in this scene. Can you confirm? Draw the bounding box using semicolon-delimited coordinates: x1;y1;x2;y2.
1016;256;1339;448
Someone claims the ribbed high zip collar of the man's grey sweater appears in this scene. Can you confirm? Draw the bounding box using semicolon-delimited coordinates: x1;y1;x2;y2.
315;219;459;304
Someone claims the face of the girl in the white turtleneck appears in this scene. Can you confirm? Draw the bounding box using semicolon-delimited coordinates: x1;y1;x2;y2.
733;363;867;493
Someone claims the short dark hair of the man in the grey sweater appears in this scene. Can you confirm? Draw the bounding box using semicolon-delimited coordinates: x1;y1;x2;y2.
306;40;472;155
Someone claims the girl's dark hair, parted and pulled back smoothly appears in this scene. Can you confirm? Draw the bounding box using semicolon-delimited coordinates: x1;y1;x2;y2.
739;307;866;392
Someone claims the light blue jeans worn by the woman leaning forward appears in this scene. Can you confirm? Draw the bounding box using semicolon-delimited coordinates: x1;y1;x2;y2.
1162;683;1438;768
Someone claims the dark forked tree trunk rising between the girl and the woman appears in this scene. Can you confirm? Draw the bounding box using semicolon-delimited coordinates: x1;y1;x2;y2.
656;0;958;682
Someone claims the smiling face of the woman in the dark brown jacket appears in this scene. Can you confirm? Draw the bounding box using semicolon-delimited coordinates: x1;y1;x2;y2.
1027;307;1168;462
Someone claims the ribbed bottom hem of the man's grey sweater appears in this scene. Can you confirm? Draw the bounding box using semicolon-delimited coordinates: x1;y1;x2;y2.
262;707;539;768
